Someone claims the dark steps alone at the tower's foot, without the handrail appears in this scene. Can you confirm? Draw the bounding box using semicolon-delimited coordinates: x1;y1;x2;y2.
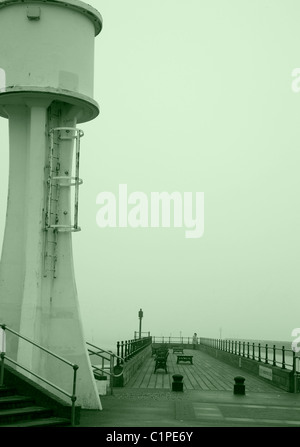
0;386;71;427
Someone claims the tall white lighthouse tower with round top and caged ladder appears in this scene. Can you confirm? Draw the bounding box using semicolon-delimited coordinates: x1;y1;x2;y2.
0;0;102;409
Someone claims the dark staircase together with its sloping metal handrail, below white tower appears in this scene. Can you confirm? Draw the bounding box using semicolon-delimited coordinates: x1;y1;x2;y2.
0;324;81;427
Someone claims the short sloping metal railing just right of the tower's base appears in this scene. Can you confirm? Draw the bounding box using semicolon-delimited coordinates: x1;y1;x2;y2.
86;342;124;394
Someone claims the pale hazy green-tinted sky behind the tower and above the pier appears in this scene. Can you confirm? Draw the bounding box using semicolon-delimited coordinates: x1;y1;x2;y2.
0;0;300;348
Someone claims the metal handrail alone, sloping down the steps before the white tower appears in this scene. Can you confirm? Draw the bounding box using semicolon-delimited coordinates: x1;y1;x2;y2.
0;324;79;426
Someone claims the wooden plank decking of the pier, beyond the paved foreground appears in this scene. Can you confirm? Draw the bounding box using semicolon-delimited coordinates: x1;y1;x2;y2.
125;349;284;392
